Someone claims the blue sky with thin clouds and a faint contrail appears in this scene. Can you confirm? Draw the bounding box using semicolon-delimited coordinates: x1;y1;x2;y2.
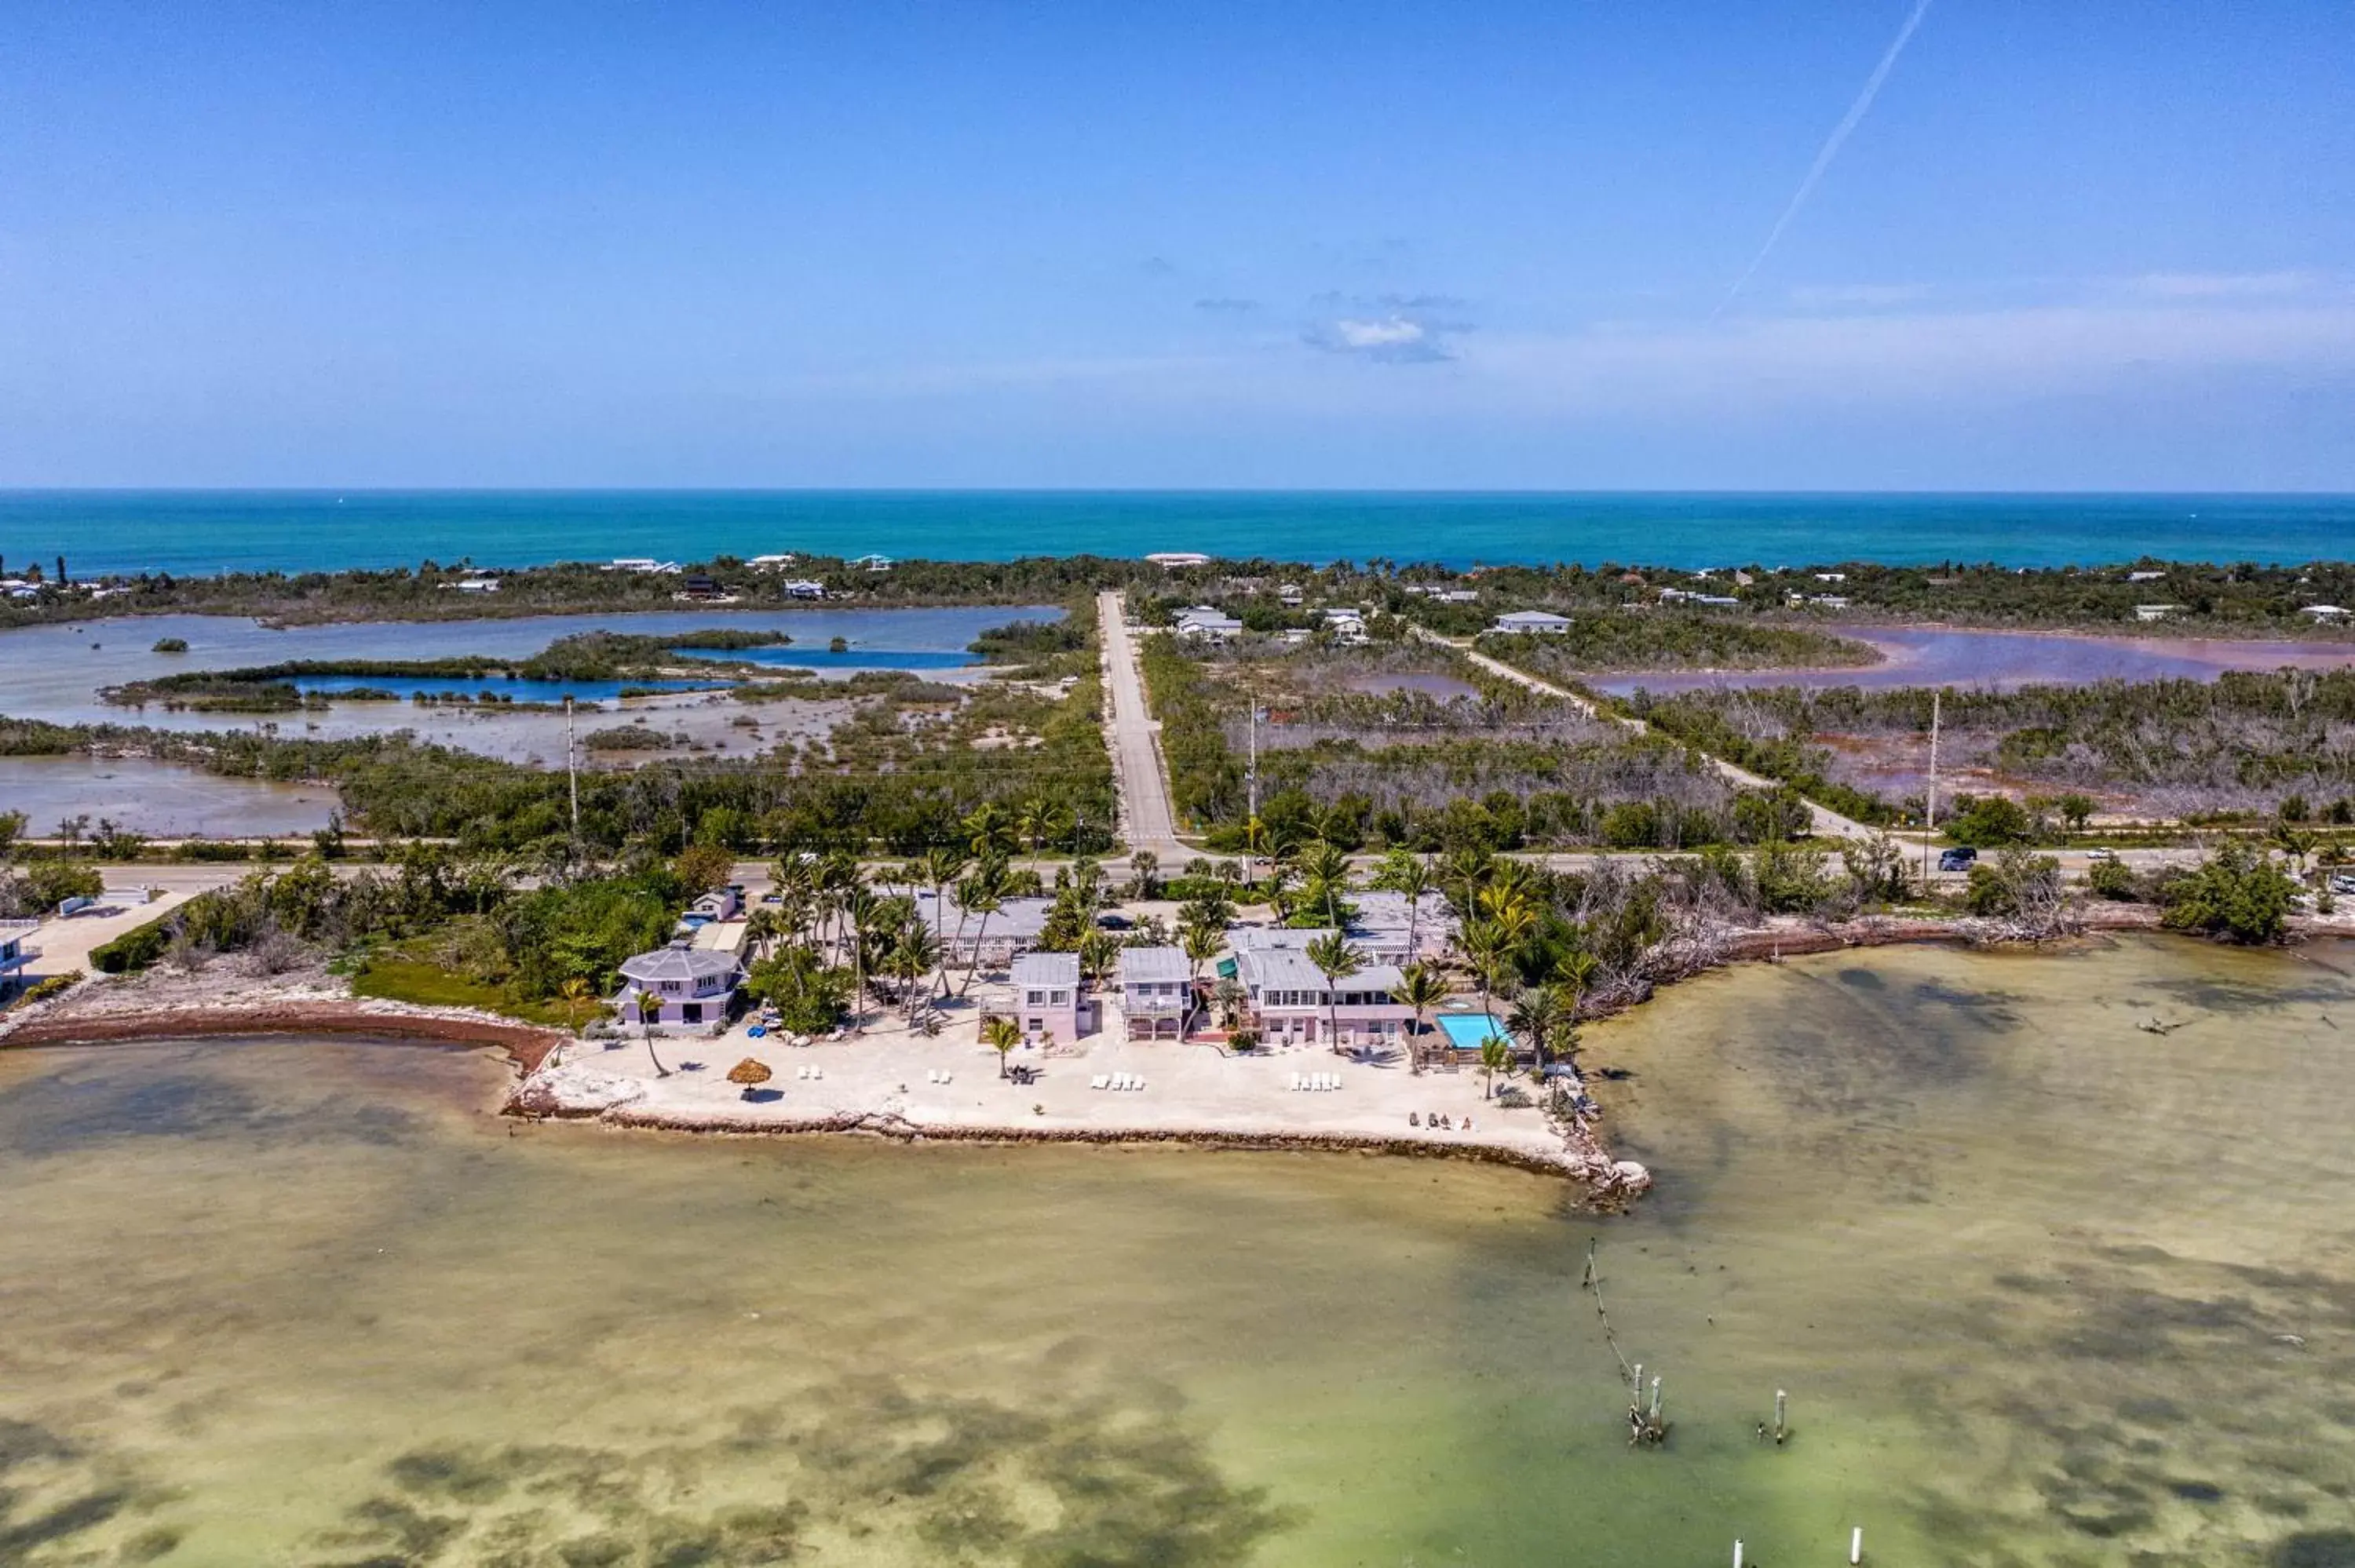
0;0;2355;490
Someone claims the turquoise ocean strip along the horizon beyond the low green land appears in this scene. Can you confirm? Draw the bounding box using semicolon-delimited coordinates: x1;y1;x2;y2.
0;490;2355;574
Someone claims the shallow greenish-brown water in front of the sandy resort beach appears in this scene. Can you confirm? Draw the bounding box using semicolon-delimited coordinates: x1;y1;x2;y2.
0;942;2355;1568
